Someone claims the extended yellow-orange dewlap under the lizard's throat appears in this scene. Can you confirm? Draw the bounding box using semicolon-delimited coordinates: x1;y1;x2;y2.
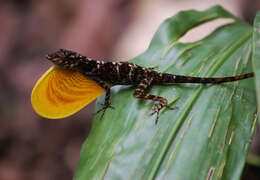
31;67;105;119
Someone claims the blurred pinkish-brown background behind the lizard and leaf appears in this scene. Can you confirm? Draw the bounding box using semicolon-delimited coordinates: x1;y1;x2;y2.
0;0;260;180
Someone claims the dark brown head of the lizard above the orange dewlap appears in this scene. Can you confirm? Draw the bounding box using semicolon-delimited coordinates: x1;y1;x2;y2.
46;49;83;69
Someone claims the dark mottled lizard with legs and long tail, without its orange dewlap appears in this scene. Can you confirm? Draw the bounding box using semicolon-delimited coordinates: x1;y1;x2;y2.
46;49;254;123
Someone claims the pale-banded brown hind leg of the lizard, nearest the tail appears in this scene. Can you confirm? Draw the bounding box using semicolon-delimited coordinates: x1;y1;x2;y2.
134;78;168;124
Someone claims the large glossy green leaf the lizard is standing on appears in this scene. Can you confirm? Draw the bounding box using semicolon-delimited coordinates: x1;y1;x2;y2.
74;6;260;180
